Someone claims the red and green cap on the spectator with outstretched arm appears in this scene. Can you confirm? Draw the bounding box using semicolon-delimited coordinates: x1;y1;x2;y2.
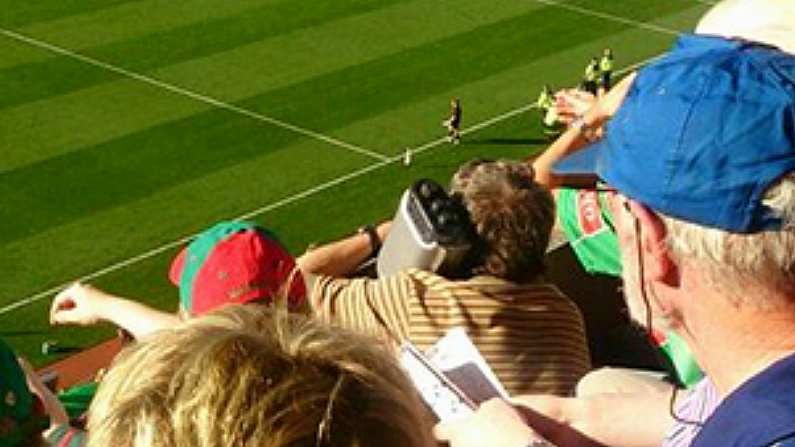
169;222;306;315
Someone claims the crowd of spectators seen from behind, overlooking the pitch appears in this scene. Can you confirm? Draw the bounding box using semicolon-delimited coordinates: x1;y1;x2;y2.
0;0;795;447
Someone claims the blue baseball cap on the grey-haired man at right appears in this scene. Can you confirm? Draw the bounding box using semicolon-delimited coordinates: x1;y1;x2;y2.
553;35;795;233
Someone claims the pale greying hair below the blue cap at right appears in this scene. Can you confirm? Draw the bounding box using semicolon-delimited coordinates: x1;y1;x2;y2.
662;173;795;309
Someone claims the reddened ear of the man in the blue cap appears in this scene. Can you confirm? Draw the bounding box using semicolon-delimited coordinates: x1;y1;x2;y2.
629;200;679;286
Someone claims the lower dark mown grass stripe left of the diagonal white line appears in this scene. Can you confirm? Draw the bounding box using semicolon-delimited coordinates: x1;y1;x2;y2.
0;104;376;244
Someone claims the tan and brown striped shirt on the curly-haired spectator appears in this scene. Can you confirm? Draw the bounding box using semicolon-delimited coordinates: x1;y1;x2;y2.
311;269;591;395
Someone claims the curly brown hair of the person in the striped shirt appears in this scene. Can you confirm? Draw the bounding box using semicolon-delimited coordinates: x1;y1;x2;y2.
450;160;555;282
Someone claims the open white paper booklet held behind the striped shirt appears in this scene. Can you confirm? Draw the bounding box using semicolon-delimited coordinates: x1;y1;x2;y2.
400;328;508;421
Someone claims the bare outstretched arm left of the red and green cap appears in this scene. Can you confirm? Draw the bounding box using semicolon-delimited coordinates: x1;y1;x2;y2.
50;283;180;338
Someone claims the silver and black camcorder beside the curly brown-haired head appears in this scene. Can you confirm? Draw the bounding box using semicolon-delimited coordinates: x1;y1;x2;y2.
376;179;477;278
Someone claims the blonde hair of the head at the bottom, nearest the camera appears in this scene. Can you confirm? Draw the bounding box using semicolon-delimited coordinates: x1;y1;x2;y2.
88;304;432;447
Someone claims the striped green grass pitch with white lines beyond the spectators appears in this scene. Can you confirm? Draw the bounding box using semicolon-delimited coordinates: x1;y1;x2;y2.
0;0;709;364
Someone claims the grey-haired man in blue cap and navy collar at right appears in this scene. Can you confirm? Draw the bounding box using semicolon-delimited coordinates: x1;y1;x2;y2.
438;26;795;447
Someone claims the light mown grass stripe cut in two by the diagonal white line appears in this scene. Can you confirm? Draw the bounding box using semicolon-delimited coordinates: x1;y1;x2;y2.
0;0;538;171
